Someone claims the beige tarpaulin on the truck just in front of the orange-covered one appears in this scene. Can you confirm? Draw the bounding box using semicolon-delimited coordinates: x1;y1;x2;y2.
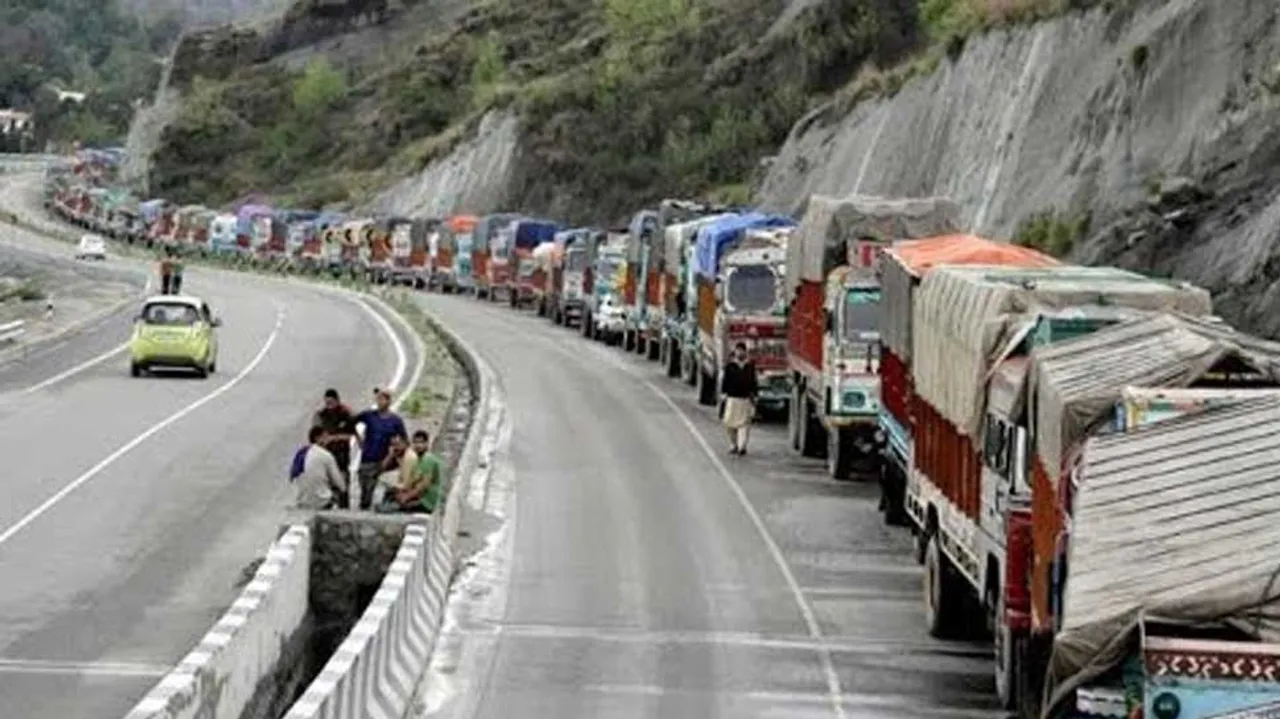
911;265;1212;436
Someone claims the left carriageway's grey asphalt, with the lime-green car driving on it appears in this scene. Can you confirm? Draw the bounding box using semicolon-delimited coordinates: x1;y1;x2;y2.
0;217;416;719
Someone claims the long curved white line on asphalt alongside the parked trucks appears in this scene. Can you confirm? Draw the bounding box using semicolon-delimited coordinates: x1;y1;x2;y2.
481;301;846;719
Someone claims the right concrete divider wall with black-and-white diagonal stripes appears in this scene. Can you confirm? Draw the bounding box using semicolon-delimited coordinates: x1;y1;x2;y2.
284;517;452;719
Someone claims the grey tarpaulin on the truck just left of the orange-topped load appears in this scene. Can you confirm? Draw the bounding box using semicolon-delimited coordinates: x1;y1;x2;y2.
787;194;960;297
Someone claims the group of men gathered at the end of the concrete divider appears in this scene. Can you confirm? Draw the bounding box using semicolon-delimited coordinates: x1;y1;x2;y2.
289;389;448;514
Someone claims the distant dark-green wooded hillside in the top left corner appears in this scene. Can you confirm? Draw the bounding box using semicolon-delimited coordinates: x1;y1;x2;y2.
0;0;179;150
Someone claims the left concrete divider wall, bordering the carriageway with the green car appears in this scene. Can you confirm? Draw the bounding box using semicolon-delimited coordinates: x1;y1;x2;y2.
125;525;311;719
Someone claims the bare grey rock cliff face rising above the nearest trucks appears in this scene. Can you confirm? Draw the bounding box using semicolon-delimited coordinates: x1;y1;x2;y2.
759;0;1280;335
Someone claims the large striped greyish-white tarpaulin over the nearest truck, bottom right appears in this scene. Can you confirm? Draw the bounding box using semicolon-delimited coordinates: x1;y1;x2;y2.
1047;395;1280;704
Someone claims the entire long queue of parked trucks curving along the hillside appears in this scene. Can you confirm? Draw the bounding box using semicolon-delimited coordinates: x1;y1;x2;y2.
42;148;1280;719
